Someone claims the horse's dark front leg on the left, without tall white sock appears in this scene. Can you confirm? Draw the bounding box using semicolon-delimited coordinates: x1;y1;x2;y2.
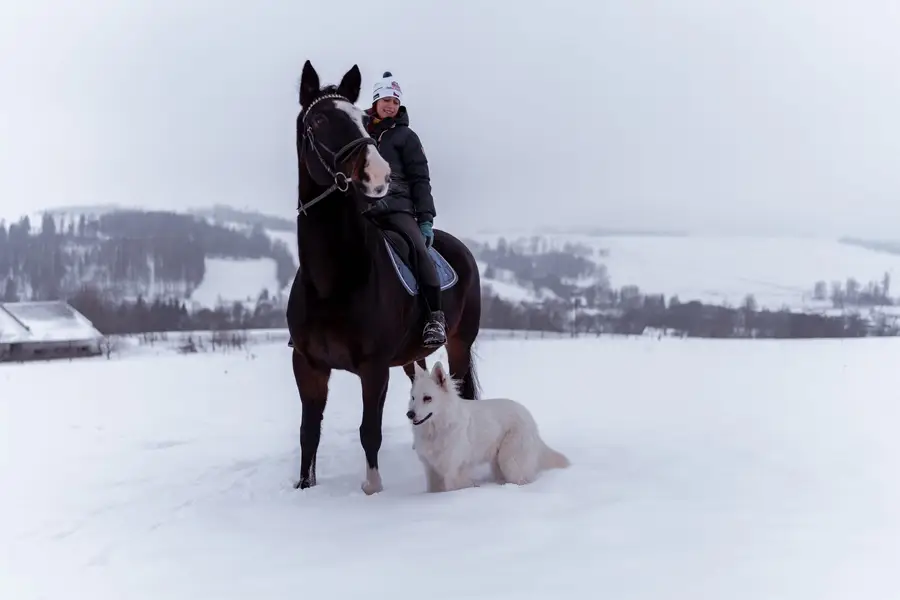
292;351;331;490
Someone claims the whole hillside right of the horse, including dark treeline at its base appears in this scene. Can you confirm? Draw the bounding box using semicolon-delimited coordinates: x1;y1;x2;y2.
458;232;900;337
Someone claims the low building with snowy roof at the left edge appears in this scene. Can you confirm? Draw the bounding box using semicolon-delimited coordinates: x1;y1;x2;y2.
0;301;103;362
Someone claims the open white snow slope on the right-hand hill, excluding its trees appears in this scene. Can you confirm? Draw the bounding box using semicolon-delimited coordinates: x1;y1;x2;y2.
473;234;900;310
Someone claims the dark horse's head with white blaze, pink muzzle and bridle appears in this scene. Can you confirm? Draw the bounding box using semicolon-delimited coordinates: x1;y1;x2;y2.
297;60;391;205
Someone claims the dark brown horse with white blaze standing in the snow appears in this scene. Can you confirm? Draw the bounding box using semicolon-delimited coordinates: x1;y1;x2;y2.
286;60;481;495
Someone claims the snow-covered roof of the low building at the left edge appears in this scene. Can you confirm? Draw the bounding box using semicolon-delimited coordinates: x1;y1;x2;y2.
0;301;103;344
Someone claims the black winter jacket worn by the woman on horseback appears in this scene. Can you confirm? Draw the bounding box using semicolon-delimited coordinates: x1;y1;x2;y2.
365;106;437;223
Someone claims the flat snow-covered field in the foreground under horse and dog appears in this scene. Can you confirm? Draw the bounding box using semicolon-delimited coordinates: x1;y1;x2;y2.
0;338;900;600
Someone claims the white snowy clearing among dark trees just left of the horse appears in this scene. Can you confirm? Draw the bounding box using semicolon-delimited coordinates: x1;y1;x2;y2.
191;258;281;308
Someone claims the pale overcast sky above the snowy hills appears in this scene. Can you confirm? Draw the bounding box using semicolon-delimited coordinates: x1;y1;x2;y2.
0;0;900;237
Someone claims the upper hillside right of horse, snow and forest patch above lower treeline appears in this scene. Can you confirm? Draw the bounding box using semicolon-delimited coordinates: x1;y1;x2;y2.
471;233;900;311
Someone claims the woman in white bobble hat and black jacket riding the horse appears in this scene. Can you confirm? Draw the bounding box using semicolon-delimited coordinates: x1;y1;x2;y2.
366;71;447;348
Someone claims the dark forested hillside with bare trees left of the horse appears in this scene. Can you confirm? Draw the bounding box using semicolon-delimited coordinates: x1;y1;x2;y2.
0;210;297;302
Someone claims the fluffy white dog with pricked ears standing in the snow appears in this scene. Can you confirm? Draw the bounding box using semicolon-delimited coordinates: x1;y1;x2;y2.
406;362;569;492
